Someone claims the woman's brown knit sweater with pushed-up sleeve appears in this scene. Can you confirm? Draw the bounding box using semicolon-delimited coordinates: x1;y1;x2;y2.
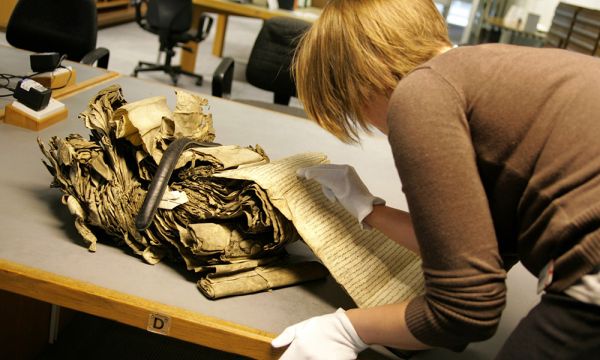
388;44;600;350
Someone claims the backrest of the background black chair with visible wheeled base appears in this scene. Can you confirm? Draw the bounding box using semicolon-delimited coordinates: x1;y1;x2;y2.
146;0;192;33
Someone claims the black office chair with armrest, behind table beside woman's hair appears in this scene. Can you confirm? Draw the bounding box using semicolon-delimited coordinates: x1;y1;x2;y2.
212;17;310;117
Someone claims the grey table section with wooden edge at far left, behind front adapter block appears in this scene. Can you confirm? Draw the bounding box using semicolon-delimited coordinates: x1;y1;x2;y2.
0;46;119;120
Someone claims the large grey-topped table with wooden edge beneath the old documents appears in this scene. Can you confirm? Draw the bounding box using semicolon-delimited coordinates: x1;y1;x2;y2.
0;72;537;359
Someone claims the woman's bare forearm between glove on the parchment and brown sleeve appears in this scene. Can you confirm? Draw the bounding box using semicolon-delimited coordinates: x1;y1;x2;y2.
364;205;420;255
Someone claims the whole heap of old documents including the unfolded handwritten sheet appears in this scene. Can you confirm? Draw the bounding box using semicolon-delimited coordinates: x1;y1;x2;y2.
40;86;423;307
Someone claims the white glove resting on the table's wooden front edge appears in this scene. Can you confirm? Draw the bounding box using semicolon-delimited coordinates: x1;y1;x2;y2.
271;309;368;360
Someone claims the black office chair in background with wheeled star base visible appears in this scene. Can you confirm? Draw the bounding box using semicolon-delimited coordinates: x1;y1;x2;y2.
133;0;213;86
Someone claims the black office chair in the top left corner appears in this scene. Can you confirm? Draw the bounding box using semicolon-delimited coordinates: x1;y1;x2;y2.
6;0;110;69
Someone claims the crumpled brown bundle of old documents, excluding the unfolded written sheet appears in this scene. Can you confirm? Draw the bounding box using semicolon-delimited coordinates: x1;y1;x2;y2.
40;86;327;298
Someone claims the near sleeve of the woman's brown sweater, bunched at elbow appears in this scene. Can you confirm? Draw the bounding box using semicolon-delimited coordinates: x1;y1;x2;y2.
388;68;506;351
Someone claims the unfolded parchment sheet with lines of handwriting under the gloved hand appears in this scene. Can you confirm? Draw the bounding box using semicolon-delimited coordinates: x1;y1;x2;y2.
216;153;423;307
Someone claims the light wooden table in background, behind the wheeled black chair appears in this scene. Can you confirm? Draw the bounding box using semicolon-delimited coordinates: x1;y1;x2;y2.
181;0;321;72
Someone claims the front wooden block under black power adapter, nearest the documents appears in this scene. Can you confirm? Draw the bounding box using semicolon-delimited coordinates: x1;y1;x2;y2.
4;99;69;131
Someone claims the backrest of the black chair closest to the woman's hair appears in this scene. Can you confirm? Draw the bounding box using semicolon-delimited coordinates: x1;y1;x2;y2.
246;17;310;102
